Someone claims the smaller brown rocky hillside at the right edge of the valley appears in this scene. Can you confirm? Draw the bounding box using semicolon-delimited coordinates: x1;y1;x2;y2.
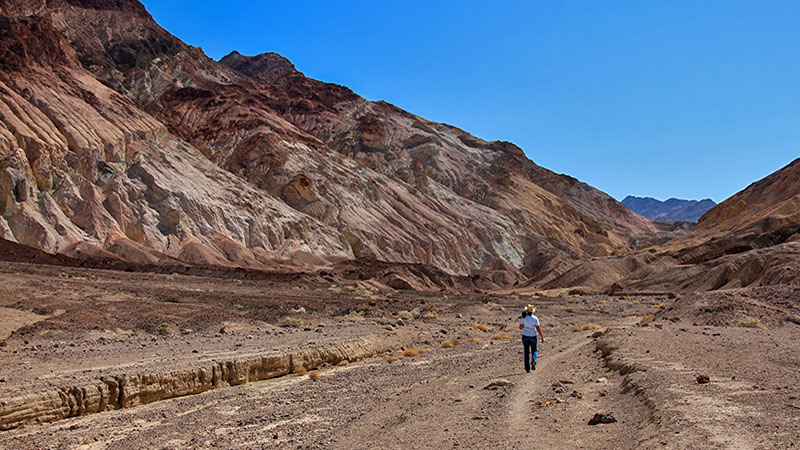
545;159;800;291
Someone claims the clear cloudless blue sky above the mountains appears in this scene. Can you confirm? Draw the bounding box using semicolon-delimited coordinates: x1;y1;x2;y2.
144;0;800;202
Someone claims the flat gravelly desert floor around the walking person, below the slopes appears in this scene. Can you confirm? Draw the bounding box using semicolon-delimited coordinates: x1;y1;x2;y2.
0;263;800;449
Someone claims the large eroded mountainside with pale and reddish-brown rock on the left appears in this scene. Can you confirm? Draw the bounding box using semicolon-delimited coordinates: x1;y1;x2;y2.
0;0;656;284
